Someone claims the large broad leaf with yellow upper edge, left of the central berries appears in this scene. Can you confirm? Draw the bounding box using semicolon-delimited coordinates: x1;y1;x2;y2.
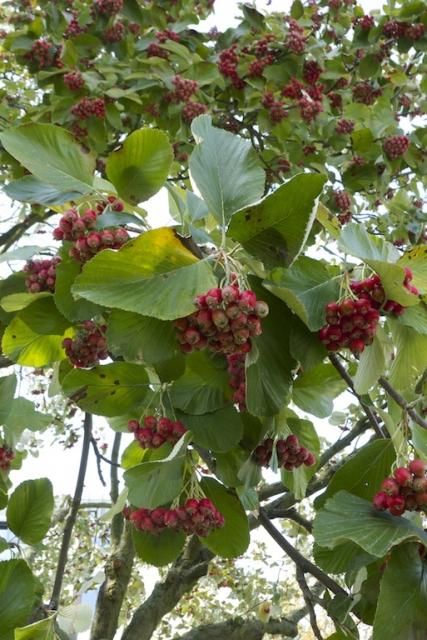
72;227;216;320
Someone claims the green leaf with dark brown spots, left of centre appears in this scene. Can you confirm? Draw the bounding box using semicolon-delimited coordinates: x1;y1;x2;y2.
62;362;149;417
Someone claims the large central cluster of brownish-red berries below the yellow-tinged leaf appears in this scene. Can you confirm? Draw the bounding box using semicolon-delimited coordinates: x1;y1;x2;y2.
175;284;268;355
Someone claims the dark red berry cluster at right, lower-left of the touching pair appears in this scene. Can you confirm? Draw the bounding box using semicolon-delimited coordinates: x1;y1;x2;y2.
319;298;380;353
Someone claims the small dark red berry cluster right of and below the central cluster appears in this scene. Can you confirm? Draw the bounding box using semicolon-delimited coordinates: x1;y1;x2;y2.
252;433;316;471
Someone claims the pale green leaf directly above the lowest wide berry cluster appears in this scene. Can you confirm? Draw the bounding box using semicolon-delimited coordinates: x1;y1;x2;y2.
123;455;185;509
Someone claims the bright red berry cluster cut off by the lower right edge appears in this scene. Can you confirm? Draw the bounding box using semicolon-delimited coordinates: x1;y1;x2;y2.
373;459;427;516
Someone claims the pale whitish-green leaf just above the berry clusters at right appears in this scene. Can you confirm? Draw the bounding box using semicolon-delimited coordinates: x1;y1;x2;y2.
339;222;400;262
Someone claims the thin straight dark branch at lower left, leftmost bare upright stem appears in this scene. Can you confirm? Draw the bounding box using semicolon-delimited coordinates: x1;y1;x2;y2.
49;413;92;610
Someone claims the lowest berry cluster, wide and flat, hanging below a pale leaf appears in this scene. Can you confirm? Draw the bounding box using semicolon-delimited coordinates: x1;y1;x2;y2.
125;498;224;538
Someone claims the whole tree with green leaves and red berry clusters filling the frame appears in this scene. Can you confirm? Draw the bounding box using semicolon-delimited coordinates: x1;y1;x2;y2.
0;0;427;640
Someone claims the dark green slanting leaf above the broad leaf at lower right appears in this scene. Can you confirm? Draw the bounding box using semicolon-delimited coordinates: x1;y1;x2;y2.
319;439;396;504
